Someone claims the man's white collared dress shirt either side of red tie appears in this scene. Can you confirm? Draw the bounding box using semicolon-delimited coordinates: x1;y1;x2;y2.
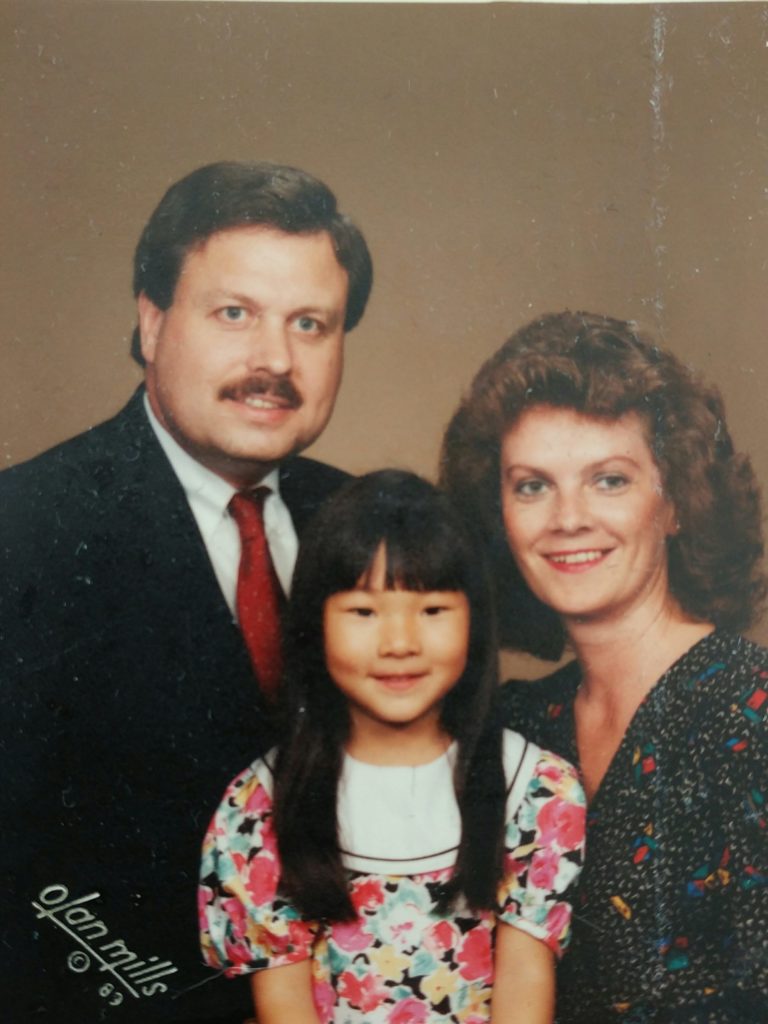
144;394;299;617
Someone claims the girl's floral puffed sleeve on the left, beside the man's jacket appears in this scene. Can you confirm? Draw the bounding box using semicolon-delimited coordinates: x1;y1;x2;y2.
198;762;316;977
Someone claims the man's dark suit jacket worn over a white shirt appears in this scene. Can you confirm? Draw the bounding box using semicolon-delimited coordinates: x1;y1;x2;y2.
0;391;345;1024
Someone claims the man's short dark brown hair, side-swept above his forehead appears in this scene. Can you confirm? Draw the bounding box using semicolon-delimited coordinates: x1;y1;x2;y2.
131;161;373;366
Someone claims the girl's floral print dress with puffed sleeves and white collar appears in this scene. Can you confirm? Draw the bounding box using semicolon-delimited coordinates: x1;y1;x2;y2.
200;731;585;1024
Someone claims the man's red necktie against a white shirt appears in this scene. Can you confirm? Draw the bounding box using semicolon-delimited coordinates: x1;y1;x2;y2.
229;487;283;696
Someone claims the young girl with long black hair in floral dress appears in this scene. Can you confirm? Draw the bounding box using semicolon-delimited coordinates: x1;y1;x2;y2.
200;470;584;1024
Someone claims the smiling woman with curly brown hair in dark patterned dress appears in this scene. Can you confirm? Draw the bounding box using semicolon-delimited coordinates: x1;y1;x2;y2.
442;313;768;1024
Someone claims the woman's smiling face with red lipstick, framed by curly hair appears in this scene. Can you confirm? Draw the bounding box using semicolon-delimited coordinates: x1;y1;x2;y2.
501;406;675;625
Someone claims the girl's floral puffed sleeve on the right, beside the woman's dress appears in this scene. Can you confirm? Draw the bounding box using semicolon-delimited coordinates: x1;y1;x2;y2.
498;751;586;956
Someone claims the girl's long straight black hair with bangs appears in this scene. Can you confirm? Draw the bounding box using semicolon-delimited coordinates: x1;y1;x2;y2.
274;470;506;921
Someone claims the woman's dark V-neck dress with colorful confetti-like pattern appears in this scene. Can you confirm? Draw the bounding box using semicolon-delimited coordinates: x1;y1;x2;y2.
503;633;768;1024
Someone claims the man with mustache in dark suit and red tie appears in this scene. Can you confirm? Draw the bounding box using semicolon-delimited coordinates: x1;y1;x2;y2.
0;163;372;1024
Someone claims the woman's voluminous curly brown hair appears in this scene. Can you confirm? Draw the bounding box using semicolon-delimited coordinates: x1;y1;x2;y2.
440;312;768;658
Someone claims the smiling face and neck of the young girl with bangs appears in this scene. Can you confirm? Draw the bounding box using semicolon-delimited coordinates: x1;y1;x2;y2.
324;546;470;753
